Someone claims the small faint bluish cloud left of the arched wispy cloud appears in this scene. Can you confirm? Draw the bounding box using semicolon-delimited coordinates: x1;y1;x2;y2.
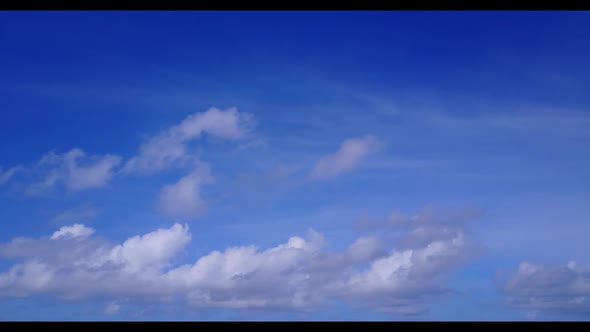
26;149;121;196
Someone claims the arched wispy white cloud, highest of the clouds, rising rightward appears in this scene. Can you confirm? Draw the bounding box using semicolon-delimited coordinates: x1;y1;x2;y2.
123;107;254;174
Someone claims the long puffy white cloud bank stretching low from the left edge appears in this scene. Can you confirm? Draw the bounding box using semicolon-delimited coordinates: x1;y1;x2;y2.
0;206;480;314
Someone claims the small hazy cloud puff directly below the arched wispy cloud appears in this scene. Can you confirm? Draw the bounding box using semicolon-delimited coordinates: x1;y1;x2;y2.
159;164;213;218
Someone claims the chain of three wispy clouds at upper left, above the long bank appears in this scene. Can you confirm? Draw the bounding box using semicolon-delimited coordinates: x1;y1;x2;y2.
0;107;255;198
